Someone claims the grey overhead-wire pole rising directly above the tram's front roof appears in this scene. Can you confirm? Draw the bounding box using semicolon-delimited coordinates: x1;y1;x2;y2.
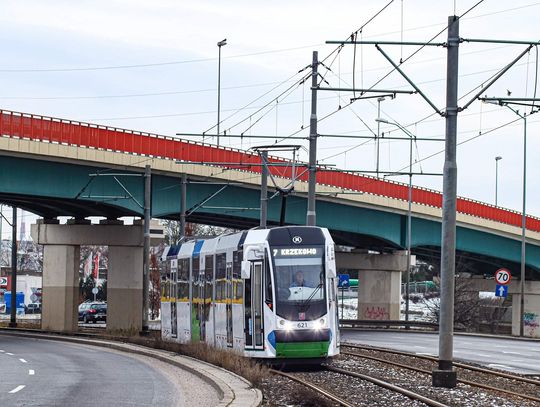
306;51;319;226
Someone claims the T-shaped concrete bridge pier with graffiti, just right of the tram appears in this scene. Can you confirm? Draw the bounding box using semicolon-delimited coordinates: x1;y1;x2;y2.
336;252;410;320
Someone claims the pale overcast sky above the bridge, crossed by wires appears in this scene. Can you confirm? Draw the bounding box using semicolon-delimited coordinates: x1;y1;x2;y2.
0;0;540;239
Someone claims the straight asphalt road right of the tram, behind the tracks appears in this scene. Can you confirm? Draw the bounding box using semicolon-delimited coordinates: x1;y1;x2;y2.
341;330;540;375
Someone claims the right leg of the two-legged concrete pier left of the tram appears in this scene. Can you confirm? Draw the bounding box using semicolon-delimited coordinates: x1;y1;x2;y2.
107;246;143;333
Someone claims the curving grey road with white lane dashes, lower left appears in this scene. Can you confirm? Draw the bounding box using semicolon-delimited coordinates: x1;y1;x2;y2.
0;334;219;407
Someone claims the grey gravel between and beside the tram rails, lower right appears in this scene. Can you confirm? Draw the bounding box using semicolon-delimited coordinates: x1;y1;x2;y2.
262;345;540;407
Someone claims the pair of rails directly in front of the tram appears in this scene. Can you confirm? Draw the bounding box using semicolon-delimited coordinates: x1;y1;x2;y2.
270;366;447;407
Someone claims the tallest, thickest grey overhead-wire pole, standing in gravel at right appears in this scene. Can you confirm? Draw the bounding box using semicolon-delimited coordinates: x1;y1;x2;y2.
432;16;460;388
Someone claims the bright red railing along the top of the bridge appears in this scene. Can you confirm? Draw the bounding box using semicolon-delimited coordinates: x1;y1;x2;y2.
0;110;540;232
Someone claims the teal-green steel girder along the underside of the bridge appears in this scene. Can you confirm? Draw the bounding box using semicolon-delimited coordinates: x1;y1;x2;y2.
0;156;540;276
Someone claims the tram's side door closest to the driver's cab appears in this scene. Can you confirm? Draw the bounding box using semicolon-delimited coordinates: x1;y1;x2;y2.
244;261;264;349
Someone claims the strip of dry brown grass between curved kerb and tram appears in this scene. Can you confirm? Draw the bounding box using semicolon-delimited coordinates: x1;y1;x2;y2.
129;336;270;387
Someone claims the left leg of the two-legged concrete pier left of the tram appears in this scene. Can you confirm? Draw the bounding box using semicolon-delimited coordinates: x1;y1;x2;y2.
41;245;80;332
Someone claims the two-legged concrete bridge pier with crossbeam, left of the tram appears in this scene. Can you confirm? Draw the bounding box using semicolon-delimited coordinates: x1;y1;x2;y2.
31;221;143;332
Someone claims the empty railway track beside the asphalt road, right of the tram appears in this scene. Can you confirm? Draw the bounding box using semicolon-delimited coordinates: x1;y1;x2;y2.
340;344;540;403
